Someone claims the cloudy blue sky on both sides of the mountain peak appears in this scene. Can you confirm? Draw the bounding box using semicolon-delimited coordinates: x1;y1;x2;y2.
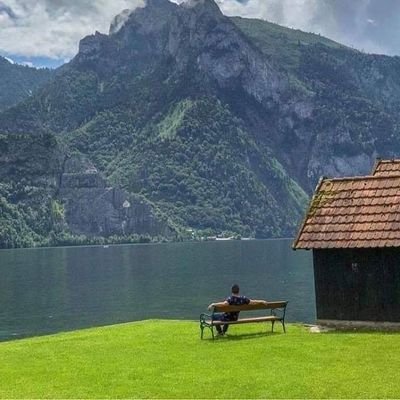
0;0;400;67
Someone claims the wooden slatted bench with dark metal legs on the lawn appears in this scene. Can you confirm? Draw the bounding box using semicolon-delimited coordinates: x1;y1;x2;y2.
200;301;288;339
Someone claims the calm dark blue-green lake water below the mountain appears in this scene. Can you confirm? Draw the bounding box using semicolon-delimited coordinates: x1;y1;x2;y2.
0;240;315;340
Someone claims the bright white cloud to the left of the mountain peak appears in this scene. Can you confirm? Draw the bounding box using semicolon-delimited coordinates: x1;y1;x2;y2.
0;0;143;59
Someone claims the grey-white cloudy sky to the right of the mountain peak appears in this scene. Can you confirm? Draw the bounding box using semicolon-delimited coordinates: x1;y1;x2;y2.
219;0;400;55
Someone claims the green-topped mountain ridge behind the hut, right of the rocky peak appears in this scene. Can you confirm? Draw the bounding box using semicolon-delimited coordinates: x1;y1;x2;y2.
234;18;400;188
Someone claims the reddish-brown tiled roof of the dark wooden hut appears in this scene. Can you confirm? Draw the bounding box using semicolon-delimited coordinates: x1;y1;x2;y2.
293;160;400;249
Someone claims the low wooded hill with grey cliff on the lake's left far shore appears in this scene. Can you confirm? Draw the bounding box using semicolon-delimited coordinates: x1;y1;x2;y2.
0;134;176;248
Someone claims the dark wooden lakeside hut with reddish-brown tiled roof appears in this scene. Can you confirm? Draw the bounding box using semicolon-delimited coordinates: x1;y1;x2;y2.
293;160;400;327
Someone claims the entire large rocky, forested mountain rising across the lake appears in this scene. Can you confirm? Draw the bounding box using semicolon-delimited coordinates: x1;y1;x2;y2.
0;0;400;247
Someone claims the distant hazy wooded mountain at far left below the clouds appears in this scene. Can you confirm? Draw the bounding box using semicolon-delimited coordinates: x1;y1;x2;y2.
0;56;53;111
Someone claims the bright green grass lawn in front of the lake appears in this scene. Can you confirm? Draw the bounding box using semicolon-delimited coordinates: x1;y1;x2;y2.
0;321;400;399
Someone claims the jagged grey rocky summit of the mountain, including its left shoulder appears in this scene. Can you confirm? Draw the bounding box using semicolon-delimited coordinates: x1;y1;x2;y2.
77;0;287;112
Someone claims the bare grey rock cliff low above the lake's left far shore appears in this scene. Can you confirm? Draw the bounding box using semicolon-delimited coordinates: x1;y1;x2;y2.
57;155;174;237
